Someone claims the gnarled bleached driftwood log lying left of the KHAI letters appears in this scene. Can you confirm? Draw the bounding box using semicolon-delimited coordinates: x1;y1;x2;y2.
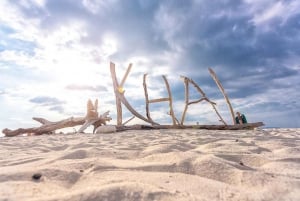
2;100;111;137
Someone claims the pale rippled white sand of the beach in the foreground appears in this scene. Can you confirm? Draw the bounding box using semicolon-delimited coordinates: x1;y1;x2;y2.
0;129;300;201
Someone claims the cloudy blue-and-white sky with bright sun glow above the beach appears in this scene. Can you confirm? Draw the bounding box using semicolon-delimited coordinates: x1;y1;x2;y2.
0;0;300;130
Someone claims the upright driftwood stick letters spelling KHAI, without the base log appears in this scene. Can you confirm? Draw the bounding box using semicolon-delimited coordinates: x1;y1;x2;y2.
110;62;262;128
